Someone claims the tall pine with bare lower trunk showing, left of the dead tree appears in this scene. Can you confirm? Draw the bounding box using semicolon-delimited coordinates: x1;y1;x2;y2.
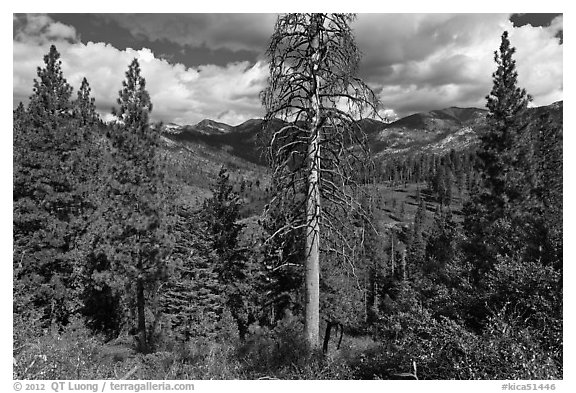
105;59;170;352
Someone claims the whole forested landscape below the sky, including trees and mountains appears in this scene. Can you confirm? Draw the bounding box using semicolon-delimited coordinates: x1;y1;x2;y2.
13;18;563;380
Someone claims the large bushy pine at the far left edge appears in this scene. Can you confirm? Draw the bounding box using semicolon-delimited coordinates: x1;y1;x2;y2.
13;46;93;325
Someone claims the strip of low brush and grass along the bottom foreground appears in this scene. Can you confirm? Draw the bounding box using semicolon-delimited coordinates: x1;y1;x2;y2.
14;306;562;380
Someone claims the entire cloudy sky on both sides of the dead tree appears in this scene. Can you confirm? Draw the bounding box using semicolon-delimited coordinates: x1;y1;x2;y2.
13;14;563;125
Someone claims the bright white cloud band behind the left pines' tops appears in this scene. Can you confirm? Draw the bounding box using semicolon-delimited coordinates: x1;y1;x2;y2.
13;16;267;124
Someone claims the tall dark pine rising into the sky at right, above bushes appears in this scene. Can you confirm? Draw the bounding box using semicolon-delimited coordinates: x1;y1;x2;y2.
464;32;531;280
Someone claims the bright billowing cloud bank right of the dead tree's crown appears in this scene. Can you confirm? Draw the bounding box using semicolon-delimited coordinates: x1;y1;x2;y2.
354;14;563;116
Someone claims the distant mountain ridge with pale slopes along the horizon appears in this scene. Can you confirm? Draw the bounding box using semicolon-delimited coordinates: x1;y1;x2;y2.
162;101;563;165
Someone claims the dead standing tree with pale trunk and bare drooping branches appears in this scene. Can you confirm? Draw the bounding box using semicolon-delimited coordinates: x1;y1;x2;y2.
262;14;377;348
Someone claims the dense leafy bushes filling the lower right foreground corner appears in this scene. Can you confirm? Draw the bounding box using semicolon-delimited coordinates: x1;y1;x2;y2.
362;302;562;380
